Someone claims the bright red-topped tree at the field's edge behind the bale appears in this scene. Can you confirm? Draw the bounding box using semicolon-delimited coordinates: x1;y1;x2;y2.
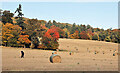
42;28;59;49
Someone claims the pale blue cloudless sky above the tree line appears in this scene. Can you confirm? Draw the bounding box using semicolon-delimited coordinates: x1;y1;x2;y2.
2;2;118;29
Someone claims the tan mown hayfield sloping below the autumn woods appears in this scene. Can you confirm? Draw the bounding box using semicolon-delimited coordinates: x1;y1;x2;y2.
2;39;118;71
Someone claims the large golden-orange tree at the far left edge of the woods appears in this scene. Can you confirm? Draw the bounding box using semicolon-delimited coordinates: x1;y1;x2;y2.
2;23;22;46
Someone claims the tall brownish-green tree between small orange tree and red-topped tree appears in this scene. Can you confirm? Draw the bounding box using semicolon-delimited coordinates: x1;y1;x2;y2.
24;19;41;47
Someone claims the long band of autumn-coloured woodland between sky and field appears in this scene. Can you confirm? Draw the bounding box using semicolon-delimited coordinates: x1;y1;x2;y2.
0;7;120;49
